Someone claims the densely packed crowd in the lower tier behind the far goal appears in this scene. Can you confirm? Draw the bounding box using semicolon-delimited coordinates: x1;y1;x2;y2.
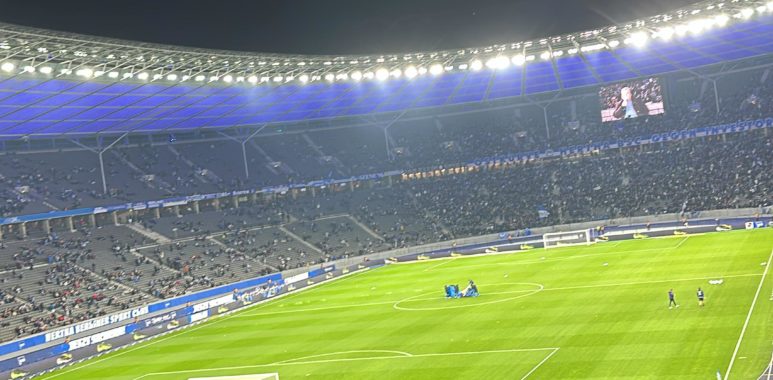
400;132;773;238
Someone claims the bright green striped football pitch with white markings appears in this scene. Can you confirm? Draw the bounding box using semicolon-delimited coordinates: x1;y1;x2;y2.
37;229;773;380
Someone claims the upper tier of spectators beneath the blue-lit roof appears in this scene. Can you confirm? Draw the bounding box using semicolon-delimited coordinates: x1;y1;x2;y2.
0;67;773;216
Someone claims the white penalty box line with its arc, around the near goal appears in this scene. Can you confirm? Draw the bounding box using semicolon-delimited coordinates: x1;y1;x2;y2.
133;347;560;380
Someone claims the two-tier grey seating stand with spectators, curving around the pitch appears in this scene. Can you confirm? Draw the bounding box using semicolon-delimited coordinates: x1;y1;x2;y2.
0;6;773;366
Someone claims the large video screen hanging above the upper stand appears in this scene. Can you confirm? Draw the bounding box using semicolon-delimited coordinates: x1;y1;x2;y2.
599;78;665;122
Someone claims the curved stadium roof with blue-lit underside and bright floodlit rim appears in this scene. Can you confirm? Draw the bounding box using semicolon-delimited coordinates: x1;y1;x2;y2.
0;0;773;136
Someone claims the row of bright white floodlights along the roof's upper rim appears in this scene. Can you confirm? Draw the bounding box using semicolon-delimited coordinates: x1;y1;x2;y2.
0;0;773;84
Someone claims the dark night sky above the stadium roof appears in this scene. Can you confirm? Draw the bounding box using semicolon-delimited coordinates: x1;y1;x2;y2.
0;0;695;54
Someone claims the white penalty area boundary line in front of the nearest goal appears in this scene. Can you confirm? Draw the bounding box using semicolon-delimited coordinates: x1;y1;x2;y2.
133;347;558;380
